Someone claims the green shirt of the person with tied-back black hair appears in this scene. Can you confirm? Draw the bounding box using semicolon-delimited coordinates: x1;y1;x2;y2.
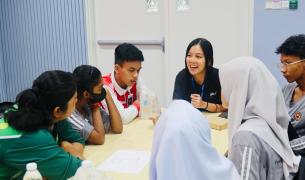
0;119;84;180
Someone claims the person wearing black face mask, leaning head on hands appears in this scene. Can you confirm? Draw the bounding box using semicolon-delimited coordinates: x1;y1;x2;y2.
68;65;123;144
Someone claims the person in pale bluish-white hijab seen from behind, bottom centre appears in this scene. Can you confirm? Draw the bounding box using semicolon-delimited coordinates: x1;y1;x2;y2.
150;100;240;180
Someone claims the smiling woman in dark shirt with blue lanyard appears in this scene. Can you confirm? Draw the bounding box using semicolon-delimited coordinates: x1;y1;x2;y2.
173;38;225;112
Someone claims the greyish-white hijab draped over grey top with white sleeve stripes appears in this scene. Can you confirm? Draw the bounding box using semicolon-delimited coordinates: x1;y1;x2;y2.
219;57;300;177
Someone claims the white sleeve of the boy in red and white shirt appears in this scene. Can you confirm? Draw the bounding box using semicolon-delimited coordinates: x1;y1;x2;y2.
102;85;138;124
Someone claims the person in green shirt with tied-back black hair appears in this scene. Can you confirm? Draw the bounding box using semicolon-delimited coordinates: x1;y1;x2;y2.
0;71;84;180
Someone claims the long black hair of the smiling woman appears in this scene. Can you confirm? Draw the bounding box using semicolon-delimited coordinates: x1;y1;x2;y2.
184;38;214;72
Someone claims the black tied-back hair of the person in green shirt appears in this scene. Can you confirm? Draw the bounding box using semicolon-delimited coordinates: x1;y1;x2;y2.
4;70;76;132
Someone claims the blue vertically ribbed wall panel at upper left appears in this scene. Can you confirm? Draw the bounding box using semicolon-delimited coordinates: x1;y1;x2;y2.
0;0;88;100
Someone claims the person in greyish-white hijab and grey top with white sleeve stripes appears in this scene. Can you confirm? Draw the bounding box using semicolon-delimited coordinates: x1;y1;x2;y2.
219;57;300;180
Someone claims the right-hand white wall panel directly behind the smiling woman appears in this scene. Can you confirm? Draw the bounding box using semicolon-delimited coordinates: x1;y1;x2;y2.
165;0;253;105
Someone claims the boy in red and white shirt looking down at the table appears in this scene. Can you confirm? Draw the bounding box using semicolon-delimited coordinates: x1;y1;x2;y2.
101;43;144;124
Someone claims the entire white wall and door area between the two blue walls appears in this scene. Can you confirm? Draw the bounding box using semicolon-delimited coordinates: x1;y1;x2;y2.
88;0;253;106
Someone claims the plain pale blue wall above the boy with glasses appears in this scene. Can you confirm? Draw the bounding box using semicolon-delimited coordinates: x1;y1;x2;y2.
253;1;305;85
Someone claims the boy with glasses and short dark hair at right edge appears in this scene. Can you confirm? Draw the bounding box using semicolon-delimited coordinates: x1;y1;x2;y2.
276;34;305;156
